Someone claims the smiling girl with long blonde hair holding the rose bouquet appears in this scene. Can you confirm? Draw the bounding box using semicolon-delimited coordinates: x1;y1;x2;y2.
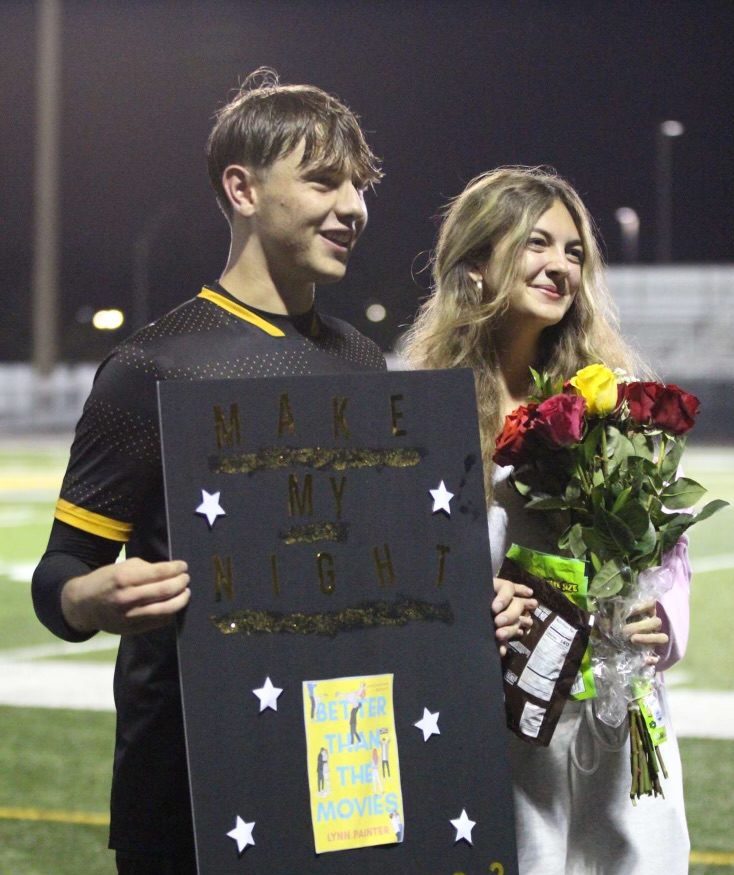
405;167;690;875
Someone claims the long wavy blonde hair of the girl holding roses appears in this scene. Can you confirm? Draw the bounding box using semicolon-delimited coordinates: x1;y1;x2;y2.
402;167;646;504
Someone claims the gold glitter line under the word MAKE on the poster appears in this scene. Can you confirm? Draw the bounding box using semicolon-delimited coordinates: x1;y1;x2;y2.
209;447;421;474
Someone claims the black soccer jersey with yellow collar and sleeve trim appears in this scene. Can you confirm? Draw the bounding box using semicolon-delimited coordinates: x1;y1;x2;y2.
37;285;385;853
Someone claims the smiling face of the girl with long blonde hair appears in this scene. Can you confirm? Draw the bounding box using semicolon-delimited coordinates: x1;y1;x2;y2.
484;200;584;330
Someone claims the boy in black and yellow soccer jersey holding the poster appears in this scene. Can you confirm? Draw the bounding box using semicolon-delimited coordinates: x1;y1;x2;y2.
33;71;385;875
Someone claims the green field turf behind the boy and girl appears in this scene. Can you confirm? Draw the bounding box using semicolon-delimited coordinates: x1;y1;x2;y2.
0;442;734;875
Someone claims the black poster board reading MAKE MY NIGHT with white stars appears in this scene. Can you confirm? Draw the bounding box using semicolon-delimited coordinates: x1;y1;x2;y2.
159;371;517;875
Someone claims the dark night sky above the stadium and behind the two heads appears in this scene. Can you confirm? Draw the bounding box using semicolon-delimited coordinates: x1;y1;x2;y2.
0;0;734;361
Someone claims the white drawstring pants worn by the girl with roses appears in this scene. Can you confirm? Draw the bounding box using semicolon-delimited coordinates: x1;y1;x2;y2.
510;690;690;875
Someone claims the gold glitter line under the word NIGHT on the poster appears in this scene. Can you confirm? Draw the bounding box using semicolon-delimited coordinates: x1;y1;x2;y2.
210;596;454;638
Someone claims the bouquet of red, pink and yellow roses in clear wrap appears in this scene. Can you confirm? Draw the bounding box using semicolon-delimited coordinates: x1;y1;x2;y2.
494;364;727;801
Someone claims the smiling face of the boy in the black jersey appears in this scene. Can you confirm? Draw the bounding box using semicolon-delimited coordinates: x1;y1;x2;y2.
252;143;367;287
